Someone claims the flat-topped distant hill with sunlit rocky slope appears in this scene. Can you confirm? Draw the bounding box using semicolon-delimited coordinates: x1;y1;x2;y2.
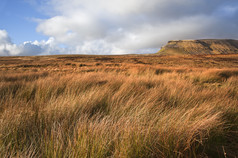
158;39;238;55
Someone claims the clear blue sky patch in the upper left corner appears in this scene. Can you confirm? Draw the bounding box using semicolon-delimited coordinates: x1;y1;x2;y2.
0;0;47;44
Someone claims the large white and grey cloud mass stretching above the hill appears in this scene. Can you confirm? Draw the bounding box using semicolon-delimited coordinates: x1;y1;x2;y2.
32;0;238;54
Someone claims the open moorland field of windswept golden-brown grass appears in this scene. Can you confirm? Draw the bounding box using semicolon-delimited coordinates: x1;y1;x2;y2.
0;55;238;157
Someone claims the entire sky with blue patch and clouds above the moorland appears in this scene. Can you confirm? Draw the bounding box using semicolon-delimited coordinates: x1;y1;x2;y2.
0;0;238;56
